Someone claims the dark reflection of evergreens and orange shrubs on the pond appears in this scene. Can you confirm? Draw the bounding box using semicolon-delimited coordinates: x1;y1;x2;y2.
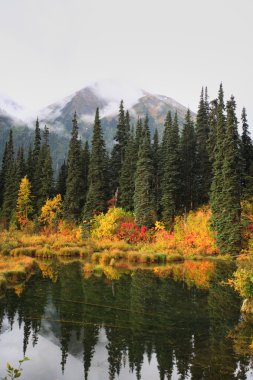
0;261;253;380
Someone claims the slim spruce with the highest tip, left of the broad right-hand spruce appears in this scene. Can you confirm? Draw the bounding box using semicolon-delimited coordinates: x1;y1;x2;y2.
210;84;226;234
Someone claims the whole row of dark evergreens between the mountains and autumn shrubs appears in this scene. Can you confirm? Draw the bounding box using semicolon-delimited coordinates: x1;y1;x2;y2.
0;84;253;253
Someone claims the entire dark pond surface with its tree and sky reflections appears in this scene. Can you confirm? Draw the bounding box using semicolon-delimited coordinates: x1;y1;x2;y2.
0;262;253;380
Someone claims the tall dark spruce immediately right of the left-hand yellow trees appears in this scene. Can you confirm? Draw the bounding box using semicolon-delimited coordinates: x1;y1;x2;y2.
63;112;84;222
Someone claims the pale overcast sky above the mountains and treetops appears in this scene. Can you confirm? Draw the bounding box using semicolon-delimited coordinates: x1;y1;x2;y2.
0;0;253;124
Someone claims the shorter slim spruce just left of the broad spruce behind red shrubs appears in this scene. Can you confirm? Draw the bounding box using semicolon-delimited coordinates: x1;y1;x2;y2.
119;128;138;211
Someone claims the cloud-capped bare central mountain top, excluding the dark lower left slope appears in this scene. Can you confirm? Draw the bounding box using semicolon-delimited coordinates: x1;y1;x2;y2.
39;83;194;149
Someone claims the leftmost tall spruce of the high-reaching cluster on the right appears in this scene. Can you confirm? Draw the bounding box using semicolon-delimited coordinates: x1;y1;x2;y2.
196;88;211;205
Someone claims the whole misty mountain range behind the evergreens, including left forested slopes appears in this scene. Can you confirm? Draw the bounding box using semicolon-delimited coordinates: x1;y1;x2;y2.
0;82;194;170
